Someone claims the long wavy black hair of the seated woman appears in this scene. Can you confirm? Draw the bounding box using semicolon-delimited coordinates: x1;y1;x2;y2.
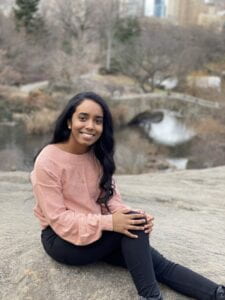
38;92;115;209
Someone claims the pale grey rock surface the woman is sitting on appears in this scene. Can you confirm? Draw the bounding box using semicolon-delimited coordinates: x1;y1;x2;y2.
0;167;225;300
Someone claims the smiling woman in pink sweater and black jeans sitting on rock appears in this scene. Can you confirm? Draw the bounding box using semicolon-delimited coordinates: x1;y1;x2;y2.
31;92;225;300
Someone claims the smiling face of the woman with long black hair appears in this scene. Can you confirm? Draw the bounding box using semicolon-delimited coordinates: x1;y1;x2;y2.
68;99;103;153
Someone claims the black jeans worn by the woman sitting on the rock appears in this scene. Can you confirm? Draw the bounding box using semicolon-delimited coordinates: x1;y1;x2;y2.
41;227;218;300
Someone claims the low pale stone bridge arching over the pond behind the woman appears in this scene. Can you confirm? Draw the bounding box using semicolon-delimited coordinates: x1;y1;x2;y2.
111;92;222;123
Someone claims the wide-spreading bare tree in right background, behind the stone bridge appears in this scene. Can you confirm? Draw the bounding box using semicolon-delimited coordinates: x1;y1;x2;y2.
116;20;224;92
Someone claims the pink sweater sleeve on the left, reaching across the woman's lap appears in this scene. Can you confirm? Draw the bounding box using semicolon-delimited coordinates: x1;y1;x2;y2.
32;165;112;245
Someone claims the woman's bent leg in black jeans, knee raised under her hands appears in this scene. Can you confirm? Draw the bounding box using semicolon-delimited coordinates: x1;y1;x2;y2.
41;227;159;297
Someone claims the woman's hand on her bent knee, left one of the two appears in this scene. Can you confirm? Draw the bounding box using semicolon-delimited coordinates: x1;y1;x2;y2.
112;209;146;238
